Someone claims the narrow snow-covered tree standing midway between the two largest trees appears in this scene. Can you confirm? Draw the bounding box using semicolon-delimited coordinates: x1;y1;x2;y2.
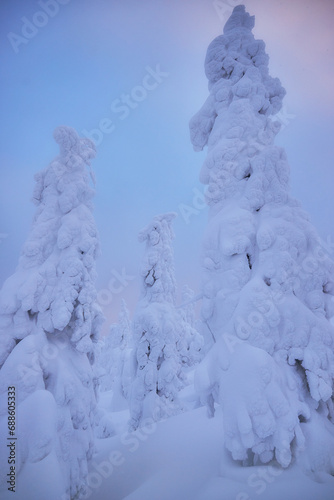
130;213;202;429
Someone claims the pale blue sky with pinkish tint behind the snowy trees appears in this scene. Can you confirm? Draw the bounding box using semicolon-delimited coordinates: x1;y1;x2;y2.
0;0;334;326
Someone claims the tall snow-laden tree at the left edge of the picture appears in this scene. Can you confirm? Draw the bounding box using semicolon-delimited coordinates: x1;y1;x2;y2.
0;126;112;499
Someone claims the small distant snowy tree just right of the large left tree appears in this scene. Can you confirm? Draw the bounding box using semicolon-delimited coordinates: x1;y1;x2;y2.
100;299;135;409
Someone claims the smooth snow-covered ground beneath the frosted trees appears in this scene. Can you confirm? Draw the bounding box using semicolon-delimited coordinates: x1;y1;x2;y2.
0;386;334;500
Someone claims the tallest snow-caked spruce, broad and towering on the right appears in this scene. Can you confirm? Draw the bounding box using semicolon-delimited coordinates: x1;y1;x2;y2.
190;5;334;471
